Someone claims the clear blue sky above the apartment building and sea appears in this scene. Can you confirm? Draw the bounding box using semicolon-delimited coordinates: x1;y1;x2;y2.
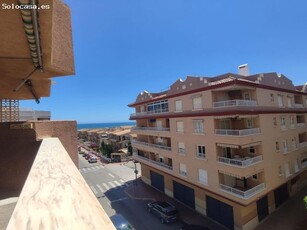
20;0;307;123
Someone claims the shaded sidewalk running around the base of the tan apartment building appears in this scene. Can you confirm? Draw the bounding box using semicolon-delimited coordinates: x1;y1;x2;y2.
125;178;307;230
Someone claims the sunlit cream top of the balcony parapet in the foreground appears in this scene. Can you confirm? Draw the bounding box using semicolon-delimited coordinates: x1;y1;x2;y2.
7;138;115;229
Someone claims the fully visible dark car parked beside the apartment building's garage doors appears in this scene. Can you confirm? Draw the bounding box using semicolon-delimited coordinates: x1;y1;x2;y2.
147;201;178;224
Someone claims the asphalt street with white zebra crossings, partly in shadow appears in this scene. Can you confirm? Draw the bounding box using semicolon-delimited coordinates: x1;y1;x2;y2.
79;155;182;230
